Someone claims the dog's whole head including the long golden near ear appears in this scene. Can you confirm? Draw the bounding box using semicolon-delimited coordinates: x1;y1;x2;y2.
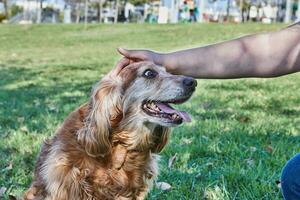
79;62;197;155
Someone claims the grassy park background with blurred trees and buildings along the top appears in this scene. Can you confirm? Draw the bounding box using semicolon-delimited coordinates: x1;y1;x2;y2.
0;0;300;200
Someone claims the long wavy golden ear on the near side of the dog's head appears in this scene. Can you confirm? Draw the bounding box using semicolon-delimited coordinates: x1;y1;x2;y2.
78;76;122;157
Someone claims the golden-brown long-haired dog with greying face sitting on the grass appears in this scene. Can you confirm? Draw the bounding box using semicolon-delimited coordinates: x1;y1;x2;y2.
23;62;197;200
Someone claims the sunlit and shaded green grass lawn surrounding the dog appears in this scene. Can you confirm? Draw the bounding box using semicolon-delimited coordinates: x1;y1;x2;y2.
0;24;300;200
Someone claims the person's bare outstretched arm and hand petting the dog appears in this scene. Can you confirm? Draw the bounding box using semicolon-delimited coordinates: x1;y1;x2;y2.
118;23;300;79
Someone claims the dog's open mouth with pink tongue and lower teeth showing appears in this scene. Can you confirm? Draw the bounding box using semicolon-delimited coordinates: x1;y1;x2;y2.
142;101;191;124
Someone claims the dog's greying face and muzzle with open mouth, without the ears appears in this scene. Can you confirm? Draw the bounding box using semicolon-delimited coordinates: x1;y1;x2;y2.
120;62;197;127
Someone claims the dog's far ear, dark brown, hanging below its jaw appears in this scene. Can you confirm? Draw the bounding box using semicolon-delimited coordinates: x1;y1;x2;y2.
151;126;171;153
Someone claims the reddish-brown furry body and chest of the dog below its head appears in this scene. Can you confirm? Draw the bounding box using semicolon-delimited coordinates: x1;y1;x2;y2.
24;104;163;200
